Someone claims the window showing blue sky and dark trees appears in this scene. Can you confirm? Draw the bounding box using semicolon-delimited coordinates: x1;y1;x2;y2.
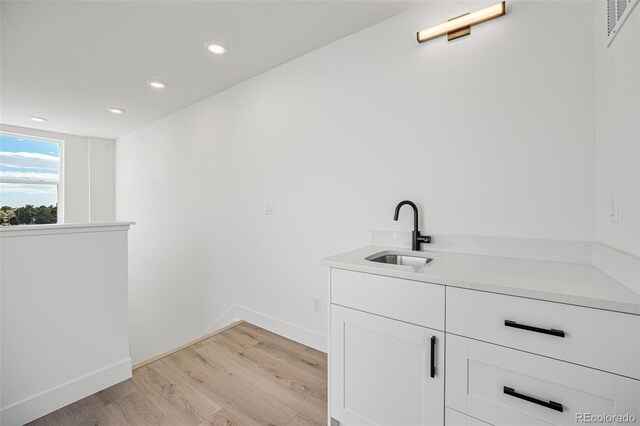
0;133;61;225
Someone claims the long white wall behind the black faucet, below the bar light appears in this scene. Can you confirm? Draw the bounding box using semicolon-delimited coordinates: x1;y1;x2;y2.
116;2;596;361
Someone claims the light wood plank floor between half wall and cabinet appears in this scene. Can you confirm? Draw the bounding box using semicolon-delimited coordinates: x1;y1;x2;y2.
30;322;327;426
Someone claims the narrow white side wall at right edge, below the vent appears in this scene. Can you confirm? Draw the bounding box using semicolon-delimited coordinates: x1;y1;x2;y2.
595;2;640;256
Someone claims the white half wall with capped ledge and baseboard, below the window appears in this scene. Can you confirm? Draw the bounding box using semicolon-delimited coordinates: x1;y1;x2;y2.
0;224;131;426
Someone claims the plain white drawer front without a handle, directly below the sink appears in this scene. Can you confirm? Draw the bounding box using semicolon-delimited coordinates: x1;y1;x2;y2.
331;269;445;330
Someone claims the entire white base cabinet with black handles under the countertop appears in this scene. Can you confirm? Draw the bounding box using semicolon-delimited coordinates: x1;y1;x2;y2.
329;268;640;426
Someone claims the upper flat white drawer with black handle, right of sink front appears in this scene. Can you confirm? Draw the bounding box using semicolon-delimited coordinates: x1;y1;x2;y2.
446;287;640;379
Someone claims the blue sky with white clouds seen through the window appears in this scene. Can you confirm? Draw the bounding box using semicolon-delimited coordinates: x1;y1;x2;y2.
0;134;60;207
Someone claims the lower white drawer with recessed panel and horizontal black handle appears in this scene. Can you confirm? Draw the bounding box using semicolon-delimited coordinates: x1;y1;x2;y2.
445;335;640;426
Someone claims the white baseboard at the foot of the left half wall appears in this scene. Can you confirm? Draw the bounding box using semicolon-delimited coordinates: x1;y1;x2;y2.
0;358;131;426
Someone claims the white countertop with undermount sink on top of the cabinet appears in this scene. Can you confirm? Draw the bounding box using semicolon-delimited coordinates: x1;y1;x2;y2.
322;246;640;315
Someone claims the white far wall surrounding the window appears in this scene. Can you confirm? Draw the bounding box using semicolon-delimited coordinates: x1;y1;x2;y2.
0;124;115;223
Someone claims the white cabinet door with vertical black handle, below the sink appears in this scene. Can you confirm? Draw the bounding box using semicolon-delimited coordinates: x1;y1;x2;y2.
330;305;444;426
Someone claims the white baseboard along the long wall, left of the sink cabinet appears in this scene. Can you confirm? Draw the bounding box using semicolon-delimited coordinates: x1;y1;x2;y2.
202;305;327;353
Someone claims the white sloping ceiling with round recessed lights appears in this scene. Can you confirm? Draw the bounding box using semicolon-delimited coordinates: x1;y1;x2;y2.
0;1;413;138
